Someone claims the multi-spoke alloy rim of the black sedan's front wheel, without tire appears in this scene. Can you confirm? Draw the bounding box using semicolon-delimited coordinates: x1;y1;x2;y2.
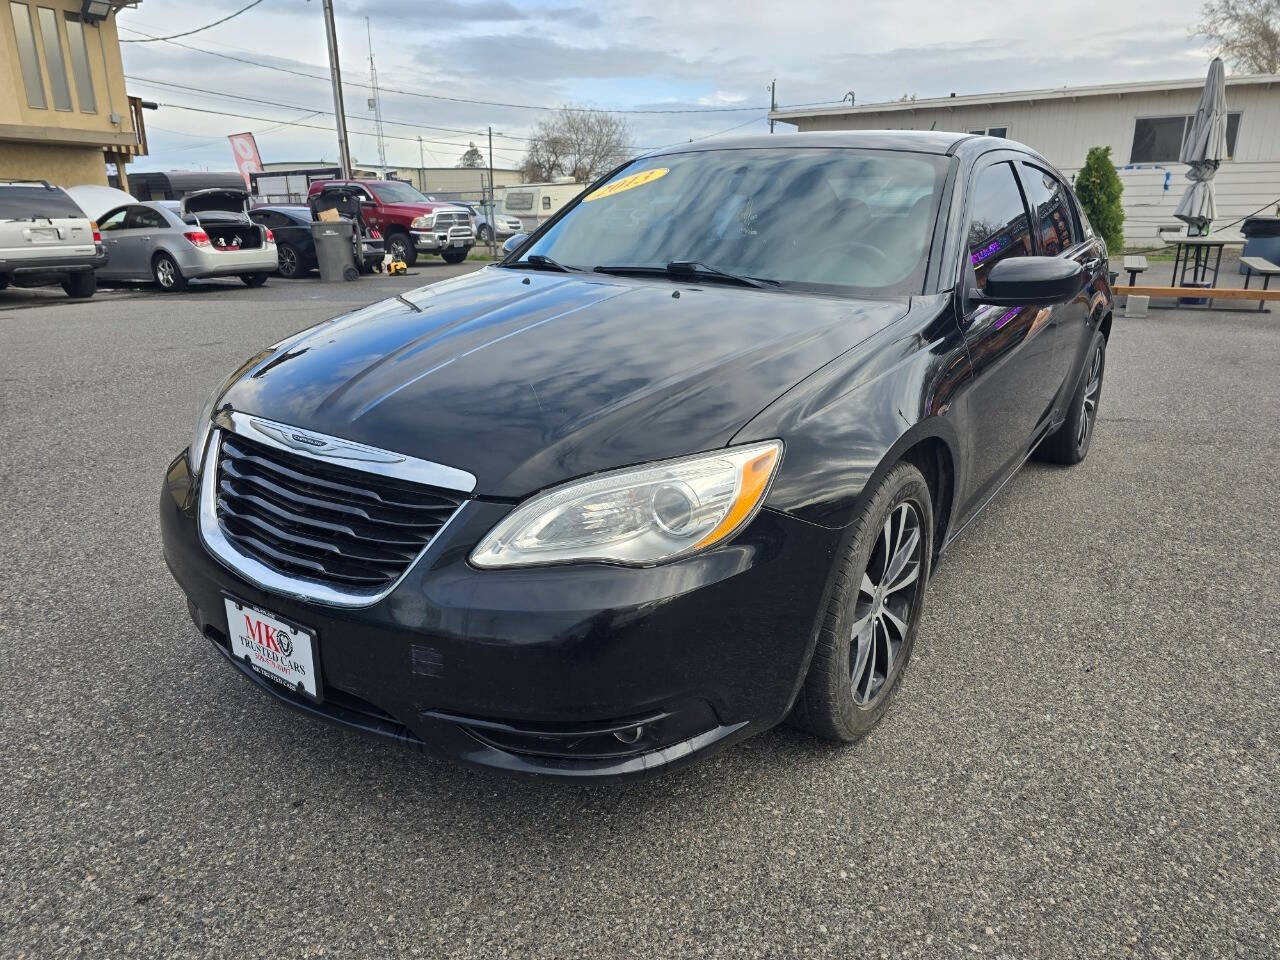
850;502;923;709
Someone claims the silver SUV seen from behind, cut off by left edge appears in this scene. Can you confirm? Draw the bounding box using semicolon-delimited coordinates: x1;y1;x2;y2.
0;180;106;298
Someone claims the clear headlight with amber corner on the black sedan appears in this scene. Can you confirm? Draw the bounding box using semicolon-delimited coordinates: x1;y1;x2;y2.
471;440;782;568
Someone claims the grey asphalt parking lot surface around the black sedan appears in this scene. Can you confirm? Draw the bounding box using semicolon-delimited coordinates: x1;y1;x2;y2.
0;271;1280;960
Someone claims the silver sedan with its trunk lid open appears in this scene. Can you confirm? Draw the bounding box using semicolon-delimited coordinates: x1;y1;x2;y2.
99;188;279;292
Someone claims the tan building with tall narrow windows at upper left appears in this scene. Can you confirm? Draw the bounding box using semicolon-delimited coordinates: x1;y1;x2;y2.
0;0;146;187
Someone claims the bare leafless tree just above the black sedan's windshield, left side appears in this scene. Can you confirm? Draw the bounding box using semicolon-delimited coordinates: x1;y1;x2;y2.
522;106;631;183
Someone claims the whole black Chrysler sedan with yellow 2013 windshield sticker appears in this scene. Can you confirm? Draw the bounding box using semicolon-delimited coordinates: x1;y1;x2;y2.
161;132;1112;778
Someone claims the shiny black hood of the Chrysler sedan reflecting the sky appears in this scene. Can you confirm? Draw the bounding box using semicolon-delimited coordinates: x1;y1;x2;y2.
221;268;908;498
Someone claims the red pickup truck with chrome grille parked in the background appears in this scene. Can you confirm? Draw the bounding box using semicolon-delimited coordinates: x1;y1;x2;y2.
307;180;476;266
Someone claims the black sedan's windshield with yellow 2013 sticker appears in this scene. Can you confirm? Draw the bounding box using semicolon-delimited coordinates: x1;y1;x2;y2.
521;148;947;296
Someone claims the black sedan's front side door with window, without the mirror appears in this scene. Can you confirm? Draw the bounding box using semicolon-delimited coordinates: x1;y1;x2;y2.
961;161;1061;515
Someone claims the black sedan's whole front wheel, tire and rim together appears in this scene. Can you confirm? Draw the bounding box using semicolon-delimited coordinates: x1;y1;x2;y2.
791;463;933;744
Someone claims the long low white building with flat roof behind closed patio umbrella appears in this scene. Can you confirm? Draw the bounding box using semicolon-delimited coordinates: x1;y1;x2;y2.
771;74;1280;244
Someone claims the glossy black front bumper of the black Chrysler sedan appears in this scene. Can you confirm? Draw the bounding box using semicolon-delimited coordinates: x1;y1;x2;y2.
160;456;837;780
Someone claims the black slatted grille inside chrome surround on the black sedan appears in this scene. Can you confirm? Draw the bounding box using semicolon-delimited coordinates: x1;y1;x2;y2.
218;433;462;590
